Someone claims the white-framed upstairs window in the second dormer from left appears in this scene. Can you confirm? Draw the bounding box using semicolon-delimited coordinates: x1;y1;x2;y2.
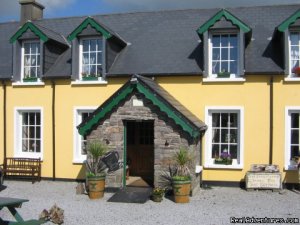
79;37;105;81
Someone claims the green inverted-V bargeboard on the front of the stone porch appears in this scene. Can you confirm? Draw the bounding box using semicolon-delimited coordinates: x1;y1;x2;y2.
77;76;201;138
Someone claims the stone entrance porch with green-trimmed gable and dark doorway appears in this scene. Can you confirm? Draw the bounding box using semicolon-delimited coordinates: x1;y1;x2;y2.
78;75;206;192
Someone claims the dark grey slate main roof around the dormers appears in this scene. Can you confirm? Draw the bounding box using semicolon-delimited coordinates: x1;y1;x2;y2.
0;5;300;79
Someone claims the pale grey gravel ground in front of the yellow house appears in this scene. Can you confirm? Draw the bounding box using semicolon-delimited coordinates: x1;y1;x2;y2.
0;181;300;225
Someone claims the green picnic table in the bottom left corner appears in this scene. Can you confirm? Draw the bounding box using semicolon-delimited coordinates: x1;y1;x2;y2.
0;197;46;225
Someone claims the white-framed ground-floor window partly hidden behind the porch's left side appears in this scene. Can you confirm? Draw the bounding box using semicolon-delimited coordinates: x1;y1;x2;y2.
73;106;97;163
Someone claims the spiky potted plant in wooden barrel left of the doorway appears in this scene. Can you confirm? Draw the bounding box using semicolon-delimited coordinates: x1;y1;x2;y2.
86;141;107;199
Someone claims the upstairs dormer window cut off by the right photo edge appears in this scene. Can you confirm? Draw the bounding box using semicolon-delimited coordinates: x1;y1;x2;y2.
290;32;300;77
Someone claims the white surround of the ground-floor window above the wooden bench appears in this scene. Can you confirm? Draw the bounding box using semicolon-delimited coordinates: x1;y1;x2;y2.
14;107;44;160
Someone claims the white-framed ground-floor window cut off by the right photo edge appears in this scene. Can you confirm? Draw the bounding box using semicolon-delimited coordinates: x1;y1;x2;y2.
285;106;300;170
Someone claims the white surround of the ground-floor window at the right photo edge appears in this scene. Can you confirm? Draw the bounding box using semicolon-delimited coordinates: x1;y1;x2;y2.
284;106;300;170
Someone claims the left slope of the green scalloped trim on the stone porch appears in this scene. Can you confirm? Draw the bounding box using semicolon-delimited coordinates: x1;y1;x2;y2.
79;85;134;135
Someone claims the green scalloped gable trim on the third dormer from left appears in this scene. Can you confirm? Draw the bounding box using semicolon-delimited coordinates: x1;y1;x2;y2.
197;9;251;34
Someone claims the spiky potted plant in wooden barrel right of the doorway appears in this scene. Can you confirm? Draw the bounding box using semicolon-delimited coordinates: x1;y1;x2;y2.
172;148;192;203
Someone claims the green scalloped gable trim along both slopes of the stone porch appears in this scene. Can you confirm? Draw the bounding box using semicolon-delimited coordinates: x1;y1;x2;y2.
79;79;200;138
